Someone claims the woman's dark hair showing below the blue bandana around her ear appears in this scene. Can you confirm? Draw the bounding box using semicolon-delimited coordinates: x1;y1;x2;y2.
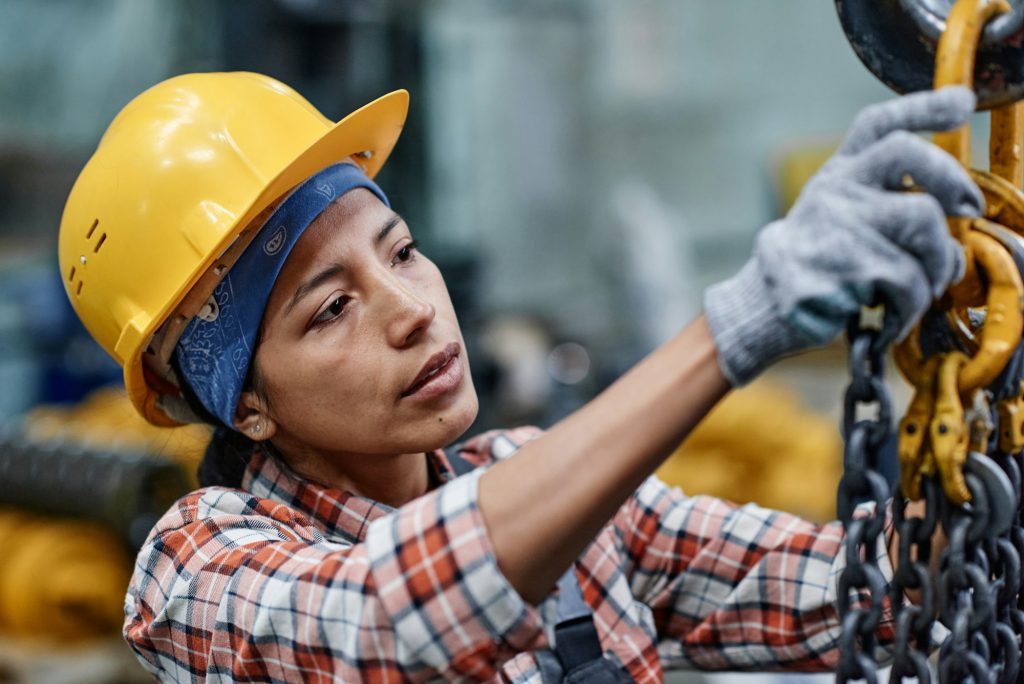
171;354;266;488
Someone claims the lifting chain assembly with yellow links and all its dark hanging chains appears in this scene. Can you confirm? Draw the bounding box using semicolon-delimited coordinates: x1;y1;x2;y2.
837;0;1024;684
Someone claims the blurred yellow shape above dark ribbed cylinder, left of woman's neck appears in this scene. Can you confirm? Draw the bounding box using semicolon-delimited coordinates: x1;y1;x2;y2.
24;387;206;487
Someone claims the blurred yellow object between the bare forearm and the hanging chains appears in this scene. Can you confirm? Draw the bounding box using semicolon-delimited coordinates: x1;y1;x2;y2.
657;380;843;521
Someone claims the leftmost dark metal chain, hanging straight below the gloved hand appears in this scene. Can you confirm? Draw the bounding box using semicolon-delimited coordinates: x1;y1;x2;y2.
836;322;892;684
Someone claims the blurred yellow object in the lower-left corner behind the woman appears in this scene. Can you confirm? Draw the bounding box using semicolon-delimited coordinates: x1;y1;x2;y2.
0;510;132;641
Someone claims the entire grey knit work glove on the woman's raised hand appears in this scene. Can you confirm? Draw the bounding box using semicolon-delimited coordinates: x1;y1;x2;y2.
705;86;984;385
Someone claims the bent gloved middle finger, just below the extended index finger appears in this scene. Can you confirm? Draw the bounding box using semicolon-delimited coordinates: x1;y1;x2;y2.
850;130;985;217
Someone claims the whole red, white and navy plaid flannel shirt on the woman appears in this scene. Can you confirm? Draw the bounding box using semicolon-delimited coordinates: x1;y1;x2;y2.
124;428;892;682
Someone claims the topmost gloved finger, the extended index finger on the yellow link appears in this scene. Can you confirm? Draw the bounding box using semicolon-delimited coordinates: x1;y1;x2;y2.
839;86;977;156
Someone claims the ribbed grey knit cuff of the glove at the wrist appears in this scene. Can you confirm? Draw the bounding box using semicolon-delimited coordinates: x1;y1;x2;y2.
703;258;806;387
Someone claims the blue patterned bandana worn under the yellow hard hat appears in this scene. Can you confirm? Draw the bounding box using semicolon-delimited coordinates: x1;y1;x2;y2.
175;164;390;429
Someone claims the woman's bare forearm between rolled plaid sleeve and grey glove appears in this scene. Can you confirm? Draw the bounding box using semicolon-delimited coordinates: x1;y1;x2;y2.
478;316;729;603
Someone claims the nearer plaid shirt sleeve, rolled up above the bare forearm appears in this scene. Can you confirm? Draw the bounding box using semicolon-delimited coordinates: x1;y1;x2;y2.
125;471;543;682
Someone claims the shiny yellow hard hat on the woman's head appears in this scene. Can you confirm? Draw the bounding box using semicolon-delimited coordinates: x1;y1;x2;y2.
58;72;409;425
